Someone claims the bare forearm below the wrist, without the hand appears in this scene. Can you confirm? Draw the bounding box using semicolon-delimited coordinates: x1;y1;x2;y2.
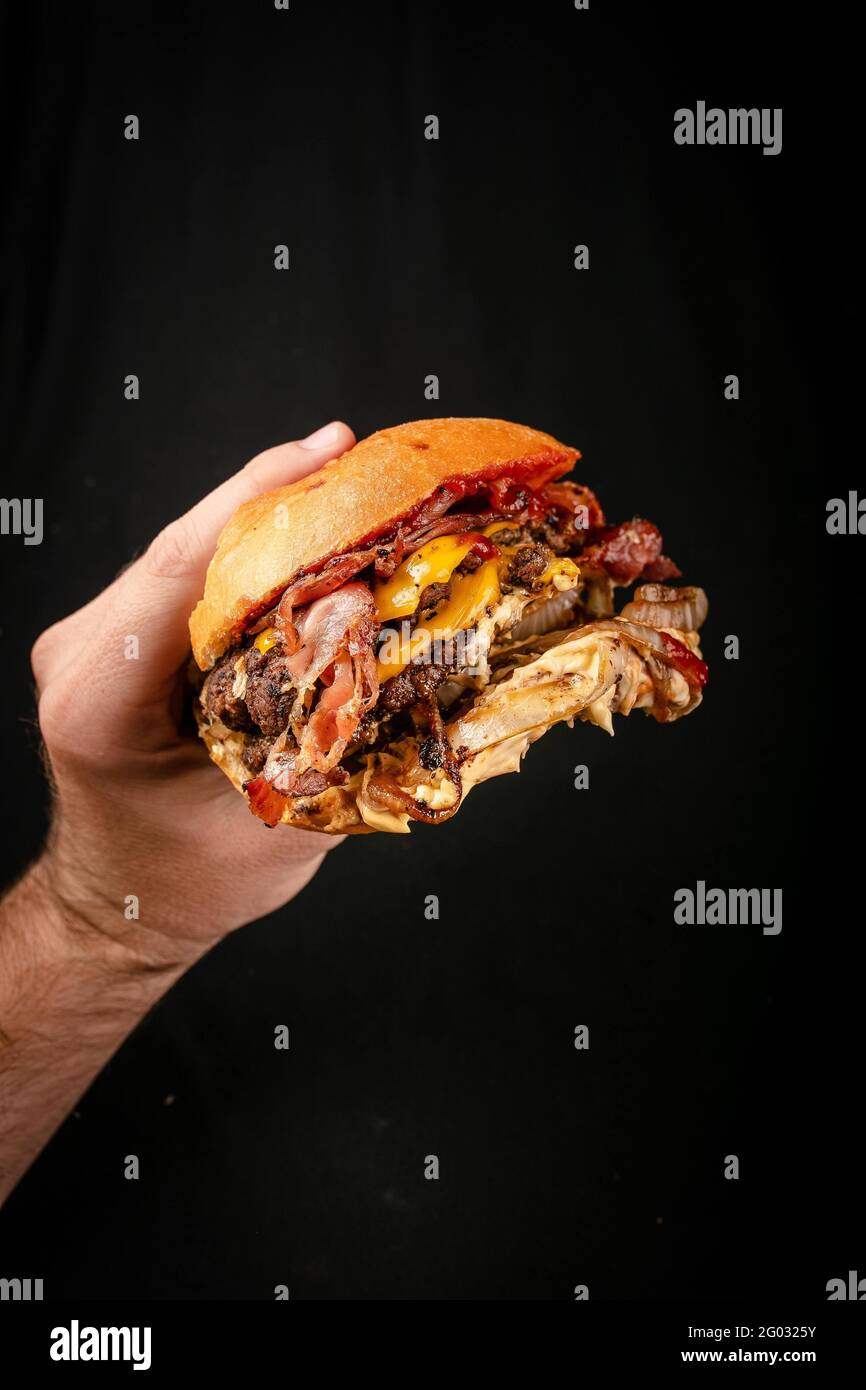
0;860;190;1202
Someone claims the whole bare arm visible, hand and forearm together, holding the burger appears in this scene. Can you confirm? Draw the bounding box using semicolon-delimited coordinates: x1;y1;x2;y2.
0;421;348;1201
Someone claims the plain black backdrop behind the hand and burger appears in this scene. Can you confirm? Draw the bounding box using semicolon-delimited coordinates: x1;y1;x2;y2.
0;0;866;1298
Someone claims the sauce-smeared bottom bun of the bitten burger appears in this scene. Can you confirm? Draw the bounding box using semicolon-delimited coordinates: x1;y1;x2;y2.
196;619;701;835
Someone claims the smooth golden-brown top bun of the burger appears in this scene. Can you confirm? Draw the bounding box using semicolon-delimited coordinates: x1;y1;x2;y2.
189;418;580;671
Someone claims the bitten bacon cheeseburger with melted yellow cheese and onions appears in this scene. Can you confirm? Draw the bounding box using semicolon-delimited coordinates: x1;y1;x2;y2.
189;418;708;834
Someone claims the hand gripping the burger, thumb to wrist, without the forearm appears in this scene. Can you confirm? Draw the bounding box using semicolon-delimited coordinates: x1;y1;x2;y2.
32;423;354;967
